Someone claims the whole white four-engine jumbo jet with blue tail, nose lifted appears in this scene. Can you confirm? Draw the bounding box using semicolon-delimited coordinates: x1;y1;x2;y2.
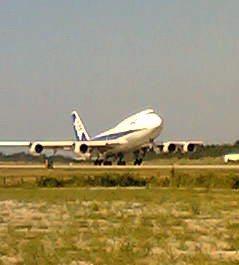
0;109;203;165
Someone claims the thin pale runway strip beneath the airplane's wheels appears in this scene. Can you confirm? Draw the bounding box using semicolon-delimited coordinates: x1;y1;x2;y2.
0;164;239;170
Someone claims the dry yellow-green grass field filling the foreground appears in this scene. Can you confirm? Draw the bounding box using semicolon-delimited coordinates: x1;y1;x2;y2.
0;188;239;265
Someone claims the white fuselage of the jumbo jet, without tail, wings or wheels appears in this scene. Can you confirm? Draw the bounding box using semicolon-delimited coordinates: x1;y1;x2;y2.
88;109;163;156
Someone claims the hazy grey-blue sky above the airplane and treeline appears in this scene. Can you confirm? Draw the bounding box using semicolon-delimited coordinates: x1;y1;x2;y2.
0;0;239;143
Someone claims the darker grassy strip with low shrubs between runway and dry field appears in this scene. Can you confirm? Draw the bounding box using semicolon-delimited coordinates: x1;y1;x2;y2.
0;167;239;189
